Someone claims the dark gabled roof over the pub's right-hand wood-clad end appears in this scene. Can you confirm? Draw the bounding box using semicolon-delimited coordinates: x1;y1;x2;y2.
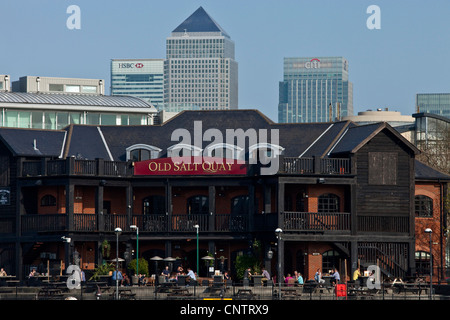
330;122;420;154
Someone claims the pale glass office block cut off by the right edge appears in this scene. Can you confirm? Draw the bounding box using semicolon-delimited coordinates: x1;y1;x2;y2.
416;93;450;118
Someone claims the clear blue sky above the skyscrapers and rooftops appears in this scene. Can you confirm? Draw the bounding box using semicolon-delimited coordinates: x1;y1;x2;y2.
0;0;450;121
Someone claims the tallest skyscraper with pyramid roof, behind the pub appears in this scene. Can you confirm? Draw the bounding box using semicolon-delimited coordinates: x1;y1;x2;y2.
164;7;238;110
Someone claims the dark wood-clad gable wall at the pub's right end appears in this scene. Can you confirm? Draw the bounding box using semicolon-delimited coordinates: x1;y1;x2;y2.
356;131;414;219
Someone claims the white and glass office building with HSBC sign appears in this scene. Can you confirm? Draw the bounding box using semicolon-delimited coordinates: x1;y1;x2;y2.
111;59;164;107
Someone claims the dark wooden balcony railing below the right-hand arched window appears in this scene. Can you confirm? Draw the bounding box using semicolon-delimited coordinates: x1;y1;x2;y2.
283;212;351;232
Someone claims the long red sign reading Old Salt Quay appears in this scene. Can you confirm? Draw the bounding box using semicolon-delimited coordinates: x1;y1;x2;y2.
134;157;247;176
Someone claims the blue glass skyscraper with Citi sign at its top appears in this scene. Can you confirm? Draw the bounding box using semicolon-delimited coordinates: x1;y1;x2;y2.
278;57;353;123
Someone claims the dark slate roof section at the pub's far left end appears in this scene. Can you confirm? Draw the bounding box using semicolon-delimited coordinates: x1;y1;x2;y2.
0;128;66;157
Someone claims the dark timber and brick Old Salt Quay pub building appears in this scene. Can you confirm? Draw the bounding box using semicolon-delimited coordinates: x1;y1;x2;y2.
0;110;449;279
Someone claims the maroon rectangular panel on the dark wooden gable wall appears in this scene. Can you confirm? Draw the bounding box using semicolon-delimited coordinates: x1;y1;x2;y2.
369;152;398;185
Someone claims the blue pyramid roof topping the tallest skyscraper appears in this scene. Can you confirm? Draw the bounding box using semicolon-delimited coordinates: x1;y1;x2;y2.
172;7;230;38
